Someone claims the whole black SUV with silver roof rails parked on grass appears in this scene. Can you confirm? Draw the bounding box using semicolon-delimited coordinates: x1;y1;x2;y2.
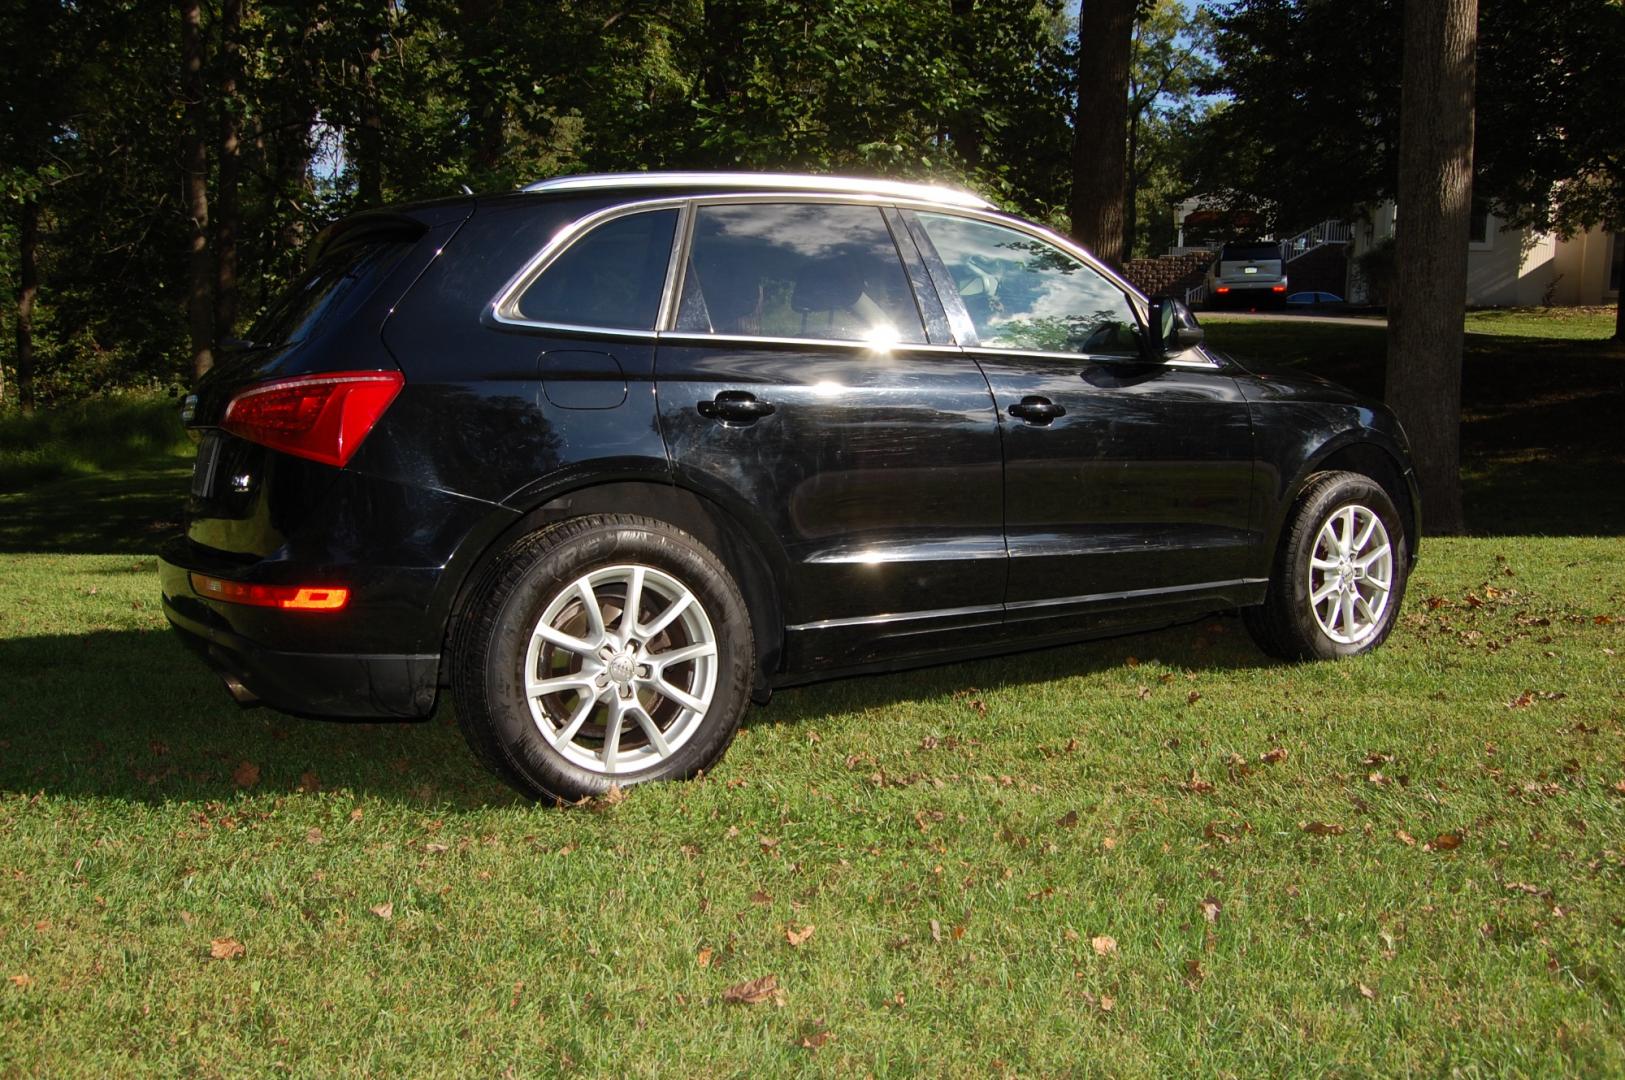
161;174;1417;799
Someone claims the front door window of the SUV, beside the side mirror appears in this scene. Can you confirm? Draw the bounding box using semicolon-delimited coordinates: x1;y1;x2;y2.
918;213;1141;357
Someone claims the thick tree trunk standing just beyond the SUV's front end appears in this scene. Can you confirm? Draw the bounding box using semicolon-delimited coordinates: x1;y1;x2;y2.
1386;0;1479;533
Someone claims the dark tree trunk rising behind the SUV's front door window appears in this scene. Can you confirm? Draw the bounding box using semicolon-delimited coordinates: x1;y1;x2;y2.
1069;0;1134;266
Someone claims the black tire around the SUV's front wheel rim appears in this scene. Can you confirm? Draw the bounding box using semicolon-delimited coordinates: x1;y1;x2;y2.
1242;473;1411;661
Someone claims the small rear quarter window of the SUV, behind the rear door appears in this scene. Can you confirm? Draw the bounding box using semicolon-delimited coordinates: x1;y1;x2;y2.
518;210;678;330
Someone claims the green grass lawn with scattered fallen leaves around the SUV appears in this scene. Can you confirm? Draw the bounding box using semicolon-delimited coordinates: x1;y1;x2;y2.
0;316;1625;1077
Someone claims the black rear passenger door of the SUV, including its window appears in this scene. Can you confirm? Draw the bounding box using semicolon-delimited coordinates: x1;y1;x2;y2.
657;197;1006;669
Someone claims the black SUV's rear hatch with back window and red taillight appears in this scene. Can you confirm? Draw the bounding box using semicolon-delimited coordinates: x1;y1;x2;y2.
182;203;473;562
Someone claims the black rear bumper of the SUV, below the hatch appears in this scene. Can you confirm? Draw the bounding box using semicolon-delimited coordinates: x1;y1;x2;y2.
158;559;440;719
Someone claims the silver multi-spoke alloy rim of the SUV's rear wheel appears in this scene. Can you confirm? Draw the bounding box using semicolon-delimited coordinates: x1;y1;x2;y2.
525;565;717;776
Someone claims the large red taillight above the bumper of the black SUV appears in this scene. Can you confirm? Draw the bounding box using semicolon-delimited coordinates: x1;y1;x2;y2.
219;372;406;466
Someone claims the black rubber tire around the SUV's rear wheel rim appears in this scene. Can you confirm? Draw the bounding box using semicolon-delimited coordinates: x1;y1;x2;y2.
452;515;756;802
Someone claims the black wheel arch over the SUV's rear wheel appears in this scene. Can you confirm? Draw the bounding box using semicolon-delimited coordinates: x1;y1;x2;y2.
440;479;788;693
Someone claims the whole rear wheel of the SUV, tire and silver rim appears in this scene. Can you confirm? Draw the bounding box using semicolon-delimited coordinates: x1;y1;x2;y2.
453;515;754;799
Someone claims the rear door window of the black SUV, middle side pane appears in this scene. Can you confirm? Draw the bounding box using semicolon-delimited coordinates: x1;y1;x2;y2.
676;203;925;344
